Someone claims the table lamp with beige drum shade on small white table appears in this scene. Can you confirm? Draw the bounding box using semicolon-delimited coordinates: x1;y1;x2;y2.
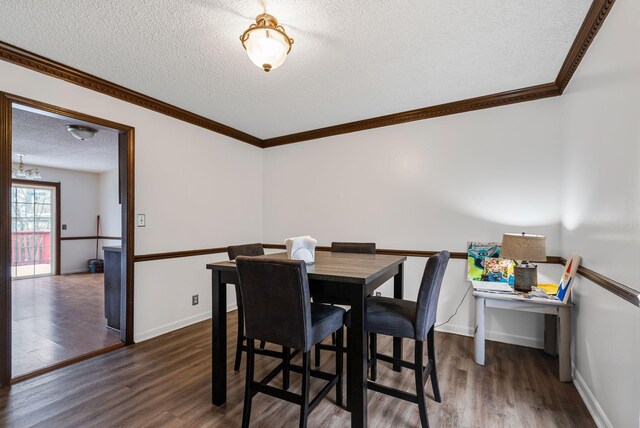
500;232;547;291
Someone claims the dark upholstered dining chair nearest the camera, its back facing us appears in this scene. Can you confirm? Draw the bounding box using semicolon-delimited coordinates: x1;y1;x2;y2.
236;256;345;428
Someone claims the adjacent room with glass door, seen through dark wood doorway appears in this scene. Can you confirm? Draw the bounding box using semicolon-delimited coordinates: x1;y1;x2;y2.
11;105;121;379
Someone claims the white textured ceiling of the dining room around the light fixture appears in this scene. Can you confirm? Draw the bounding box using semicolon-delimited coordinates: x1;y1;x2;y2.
0;0;590;138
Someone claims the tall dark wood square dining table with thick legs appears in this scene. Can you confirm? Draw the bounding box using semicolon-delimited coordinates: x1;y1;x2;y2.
207;251;407;427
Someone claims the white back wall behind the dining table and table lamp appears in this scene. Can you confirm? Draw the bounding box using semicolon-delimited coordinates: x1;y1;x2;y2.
264;99;561;347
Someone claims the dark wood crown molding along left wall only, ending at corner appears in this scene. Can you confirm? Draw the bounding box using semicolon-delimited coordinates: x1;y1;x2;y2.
0;41;262;147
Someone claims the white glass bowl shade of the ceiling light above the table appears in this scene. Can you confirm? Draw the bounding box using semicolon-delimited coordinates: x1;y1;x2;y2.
245;29;289;71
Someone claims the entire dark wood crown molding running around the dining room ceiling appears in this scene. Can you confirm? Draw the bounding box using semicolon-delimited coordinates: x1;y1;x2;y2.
0;0;615;148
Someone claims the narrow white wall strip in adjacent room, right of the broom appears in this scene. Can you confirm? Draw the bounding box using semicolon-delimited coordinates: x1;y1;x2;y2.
98;169;122;258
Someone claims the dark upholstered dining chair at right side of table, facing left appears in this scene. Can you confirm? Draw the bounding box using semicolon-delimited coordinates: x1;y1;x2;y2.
345;251;449;428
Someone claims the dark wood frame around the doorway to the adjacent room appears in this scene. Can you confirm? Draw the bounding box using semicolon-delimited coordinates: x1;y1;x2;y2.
0;92;135;386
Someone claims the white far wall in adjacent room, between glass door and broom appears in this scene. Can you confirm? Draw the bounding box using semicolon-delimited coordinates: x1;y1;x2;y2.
13;166;99;274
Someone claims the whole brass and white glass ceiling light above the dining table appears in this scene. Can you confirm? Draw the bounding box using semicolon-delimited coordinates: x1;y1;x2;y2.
240;4;293;72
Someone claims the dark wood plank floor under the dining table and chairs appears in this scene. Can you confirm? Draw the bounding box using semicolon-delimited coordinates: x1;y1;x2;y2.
0;313;595;428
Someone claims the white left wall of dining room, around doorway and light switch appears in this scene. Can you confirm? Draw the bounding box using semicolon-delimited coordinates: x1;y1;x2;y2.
0;61;262;340
